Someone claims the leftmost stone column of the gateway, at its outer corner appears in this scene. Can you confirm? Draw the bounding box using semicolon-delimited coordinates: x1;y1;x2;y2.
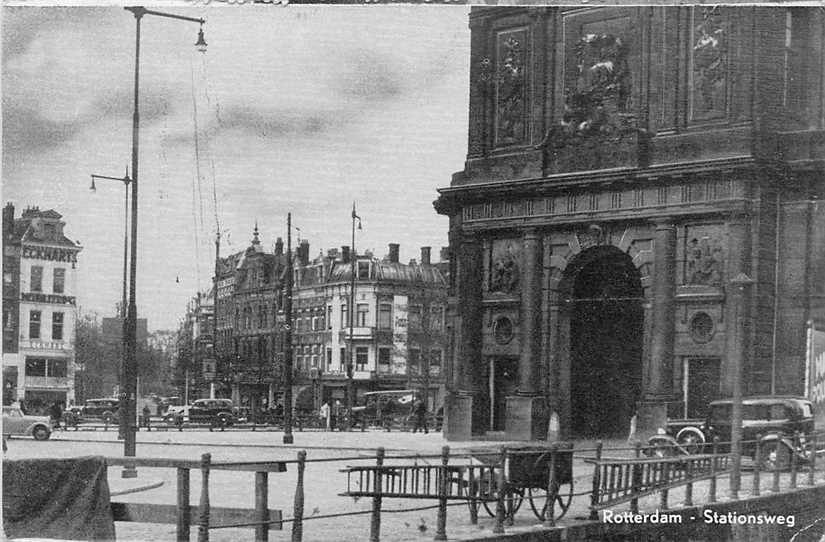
444;236;484;440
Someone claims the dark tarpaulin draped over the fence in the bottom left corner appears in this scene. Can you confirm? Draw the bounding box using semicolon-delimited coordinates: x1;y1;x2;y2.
3;457;115;540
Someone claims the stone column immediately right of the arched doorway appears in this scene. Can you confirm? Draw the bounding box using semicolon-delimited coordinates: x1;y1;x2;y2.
637;220;676;437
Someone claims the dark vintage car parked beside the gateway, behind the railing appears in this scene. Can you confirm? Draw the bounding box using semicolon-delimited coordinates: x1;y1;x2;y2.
647;395;814;470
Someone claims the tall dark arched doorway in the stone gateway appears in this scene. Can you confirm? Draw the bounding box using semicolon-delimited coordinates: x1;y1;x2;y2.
567;246;644;437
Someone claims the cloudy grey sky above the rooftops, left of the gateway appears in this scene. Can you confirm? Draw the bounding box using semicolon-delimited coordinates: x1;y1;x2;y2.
2;5;469;329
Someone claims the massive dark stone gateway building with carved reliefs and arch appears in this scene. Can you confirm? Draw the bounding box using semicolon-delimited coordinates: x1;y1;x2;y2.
435;6;825;440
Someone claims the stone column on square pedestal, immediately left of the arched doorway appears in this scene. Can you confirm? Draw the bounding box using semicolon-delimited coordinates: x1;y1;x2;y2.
505;229;547;440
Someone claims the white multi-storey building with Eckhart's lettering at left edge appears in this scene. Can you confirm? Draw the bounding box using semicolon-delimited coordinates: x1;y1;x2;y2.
3;203;81;411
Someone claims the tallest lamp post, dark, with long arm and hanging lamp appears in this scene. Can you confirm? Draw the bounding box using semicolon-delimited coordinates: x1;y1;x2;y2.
121;6;206;478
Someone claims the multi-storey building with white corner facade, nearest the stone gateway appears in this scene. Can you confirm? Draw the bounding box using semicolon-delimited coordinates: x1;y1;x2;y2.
293;242;448;410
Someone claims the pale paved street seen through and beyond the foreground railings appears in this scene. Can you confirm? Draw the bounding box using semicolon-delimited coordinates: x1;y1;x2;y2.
7;431;632;542
